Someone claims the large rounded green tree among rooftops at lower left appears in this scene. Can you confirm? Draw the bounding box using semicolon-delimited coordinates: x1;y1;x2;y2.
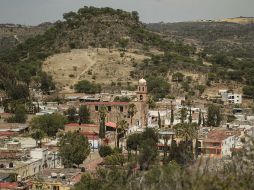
59;132;90;168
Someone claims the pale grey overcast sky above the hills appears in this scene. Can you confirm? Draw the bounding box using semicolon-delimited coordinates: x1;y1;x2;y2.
0;0;254;25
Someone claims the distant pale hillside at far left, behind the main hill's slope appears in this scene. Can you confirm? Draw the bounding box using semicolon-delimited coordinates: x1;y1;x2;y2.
0;23;52;52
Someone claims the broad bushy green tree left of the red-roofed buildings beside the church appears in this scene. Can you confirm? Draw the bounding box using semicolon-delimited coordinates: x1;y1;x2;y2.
29;113;66;137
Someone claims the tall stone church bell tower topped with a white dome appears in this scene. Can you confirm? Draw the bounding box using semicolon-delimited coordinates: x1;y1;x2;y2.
136;78;148;128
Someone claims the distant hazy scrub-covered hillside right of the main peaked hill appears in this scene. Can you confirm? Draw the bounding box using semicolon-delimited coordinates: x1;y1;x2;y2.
147;21;254;58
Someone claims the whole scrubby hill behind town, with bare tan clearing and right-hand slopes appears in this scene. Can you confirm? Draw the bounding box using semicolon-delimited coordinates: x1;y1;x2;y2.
0;7;254;99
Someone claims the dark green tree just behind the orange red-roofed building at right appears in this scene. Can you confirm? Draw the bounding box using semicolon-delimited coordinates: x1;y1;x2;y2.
207;104;222;127
